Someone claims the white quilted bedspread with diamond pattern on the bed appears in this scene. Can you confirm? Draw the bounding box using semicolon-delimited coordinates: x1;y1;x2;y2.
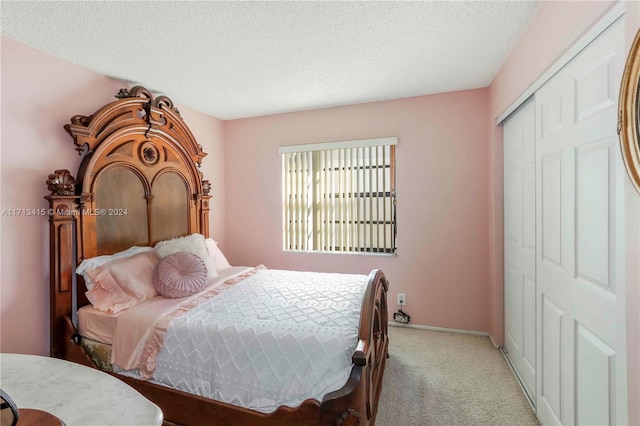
154;270;368;413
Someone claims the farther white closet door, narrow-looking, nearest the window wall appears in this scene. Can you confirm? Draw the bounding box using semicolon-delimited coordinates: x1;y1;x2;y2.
503;101;536;406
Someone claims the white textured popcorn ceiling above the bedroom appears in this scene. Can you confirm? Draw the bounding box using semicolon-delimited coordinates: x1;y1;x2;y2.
1;0;542;119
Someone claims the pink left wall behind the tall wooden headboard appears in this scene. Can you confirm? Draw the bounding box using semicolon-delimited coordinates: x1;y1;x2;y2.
0;37;224;355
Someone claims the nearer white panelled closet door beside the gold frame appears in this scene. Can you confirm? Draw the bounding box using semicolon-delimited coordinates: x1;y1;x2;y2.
536;19;627;425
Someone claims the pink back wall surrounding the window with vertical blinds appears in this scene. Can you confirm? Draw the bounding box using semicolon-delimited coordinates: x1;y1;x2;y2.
225;89;489;331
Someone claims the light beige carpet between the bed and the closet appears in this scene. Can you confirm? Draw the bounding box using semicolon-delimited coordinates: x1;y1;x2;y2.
376;326;539;426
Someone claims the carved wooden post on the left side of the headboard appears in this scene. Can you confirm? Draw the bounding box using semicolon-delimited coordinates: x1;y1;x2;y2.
44;170;78;358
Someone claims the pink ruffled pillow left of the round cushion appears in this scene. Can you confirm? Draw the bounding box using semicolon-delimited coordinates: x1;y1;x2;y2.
85;251;158;314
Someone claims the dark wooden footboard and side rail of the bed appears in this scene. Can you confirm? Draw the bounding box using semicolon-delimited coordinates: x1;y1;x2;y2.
55;270;389;426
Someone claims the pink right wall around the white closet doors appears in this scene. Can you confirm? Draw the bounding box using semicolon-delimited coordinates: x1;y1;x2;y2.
487;1;640;425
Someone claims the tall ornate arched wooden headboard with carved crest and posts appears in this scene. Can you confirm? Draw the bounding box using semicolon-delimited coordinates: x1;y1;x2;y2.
45;86;211;356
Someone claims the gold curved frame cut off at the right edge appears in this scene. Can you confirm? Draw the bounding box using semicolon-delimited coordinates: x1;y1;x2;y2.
618;30;640;192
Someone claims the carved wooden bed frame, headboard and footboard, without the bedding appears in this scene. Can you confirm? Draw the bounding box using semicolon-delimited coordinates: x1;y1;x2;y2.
45;86;388;425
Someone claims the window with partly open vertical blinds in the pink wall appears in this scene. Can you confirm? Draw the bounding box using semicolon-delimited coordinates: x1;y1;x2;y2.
280;138;398;253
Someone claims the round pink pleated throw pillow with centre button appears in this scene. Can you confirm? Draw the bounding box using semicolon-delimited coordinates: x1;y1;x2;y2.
153;251;207;298
